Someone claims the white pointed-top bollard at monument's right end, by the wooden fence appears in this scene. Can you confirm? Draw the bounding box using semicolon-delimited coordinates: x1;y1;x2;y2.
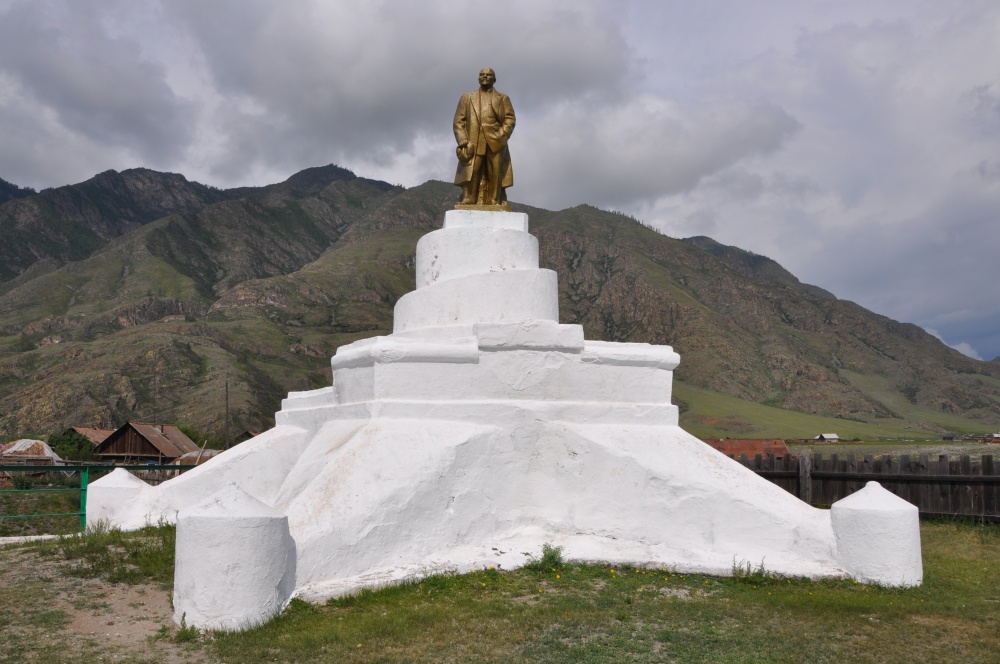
830;482;924;586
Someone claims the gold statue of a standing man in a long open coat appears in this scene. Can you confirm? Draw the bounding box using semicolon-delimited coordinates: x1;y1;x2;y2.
455;67;514;207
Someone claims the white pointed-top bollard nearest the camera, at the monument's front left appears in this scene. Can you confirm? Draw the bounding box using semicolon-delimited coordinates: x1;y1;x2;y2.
174;483;295;631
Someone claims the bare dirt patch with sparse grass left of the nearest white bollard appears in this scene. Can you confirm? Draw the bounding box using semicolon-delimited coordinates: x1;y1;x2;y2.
0;546;213;663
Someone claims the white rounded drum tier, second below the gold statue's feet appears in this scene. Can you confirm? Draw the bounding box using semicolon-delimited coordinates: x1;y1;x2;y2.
416;226;538;288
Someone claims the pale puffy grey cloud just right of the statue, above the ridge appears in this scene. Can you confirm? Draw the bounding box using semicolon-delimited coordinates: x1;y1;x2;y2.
511;98;799;207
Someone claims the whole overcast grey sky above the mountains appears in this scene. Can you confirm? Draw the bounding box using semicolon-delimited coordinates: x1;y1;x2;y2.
0;0;1000;359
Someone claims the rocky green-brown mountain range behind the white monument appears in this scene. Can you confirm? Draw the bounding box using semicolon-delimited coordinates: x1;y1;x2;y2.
0;166;1000;436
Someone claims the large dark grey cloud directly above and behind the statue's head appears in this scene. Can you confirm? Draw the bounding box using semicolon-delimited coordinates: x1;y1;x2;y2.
165;1;628;184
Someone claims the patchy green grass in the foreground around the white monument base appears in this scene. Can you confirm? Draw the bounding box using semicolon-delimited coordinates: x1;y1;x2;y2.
0;522;1000;663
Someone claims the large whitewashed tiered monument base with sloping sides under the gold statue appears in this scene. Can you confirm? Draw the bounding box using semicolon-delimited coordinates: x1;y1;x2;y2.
88;211;921;624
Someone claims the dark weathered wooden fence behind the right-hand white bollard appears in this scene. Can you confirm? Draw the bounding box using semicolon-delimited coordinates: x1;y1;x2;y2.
732;451;1000;522
